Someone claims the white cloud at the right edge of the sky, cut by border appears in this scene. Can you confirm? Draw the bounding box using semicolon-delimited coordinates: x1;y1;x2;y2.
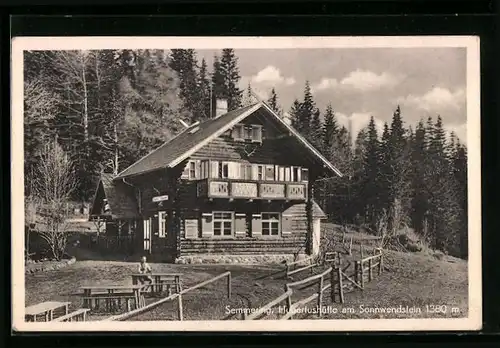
396;87;465;113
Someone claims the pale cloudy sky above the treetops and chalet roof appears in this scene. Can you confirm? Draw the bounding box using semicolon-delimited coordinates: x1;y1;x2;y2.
197;47;466;143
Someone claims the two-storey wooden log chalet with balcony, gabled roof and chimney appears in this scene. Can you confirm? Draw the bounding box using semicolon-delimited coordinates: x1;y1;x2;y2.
91;101;341;263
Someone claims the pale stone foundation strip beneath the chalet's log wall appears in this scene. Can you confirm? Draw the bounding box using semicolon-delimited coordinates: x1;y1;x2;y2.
175;254;307;265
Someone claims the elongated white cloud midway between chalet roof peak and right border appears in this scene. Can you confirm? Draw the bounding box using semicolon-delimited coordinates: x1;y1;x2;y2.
311;69;403;92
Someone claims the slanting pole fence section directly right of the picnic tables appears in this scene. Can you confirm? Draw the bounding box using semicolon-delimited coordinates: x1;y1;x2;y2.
103;271;231;321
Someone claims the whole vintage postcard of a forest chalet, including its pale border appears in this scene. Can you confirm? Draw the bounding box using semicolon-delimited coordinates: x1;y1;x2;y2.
11;36;482;331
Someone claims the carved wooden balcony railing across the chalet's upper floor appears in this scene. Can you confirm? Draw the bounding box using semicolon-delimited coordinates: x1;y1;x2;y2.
197;179;307;201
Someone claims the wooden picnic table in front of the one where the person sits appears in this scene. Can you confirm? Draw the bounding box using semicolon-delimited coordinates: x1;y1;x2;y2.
81;284;146;312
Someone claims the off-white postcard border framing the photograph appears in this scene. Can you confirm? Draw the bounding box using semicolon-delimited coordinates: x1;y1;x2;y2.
11;36;482;332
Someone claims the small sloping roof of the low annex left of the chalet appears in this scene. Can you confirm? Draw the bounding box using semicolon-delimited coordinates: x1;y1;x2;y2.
92;173;139;219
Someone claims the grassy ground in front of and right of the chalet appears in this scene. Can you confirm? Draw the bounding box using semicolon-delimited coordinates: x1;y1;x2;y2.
25;245;468;320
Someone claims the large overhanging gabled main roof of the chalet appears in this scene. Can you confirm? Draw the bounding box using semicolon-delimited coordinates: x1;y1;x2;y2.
116;102;342;179
